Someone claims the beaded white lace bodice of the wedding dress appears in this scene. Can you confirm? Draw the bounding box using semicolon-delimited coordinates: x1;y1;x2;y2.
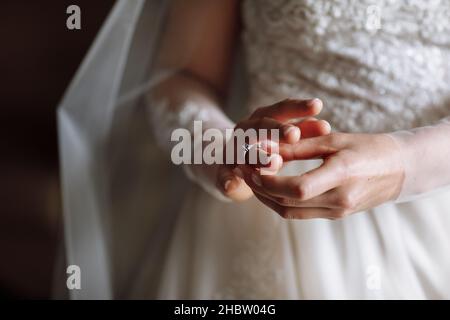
243;0;450;132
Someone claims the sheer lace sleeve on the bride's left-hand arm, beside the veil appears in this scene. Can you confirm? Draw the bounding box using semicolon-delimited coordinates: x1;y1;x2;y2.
147;75;234;200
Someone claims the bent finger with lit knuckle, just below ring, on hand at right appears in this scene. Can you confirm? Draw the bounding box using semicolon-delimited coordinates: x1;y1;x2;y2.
252;161;347;201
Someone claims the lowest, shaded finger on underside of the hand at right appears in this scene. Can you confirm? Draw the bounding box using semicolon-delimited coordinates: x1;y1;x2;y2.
255;193;333;219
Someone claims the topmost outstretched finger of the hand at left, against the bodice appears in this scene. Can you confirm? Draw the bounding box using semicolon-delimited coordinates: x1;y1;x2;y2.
250;98;323;122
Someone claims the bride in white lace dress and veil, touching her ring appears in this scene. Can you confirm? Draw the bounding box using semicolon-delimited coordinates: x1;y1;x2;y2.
59;0;450;299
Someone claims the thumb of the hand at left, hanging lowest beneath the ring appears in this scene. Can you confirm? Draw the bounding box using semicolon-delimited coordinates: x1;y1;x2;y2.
217;166;253;201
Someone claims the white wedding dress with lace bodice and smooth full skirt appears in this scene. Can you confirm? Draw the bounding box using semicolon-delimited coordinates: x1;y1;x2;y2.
149;0;450;299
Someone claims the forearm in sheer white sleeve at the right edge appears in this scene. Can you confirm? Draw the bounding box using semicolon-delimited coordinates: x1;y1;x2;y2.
389;117;450;202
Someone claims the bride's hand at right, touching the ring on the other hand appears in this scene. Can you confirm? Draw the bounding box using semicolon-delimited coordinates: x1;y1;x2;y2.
243;133;404;219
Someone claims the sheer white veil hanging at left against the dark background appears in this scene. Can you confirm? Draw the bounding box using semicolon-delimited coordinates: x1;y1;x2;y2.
58;0;245;299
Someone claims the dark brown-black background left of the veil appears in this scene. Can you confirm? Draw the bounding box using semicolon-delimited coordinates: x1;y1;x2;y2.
0;0;114;298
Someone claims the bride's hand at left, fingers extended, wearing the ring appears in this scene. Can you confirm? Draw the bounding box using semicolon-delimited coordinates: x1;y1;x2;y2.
215;99;330;201
